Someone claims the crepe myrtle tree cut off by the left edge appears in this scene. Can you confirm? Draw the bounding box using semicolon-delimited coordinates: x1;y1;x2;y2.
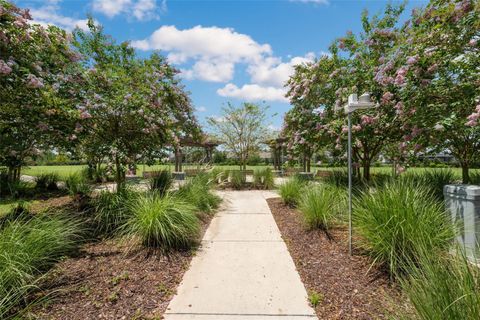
0;0;82;181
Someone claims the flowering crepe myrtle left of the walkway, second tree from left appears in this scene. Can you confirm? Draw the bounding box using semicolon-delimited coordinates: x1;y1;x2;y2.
74;19;198;186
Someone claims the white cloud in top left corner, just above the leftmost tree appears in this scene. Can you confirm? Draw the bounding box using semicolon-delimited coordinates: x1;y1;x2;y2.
30;0;88;30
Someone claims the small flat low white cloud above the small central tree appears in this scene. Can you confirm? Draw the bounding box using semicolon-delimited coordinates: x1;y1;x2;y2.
217;83;288;102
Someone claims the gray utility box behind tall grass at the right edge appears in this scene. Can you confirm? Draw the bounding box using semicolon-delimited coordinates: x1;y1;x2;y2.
443;184;480;261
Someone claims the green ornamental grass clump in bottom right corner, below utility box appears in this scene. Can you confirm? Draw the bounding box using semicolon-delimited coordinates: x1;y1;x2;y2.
402;251;480;320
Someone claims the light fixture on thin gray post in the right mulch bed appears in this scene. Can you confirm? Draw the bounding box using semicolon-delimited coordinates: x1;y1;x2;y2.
344;93;378;255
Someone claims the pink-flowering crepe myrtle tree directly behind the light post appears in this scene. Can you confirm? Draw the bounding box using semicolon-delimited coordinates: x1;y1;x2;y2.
289;5;406;180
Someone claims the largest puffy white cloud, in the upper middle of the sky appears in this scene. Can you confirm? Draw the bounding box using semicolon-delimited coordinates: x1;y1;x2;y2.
132;26;272;82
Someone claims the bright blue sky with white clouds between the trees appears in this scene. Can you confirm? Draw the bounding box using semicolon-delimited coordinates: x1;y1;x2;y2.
15;0;426;127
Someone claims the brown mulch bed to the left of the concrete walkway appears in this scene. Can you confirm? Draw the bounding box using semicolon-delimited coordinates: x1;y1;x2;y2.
31;217;211;320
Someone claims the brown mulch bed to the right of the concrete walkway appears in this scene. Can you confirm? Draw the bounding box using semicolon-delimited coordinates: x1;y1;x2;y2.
267;198;409;319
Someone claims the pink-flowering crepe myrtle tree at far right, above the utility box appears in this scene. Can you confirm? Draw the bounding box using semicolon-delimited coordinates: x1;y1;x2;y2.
379;0;480;183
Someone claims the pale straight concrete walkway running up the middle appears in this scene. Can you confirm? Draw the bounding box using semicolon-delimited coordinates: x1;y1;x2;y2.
165;191;317;320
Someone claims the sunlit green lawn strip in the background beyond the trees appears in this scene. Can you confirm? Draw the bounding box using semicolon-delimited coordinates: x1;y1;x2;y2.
22;164;480;178
